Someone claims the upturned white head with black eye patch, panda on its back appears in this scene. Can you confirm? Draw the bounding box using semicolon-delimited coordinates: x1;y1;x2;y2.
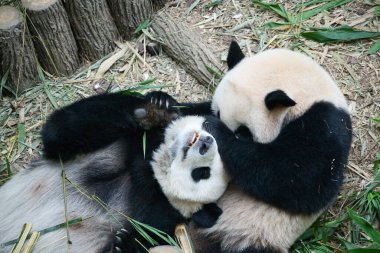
151;116;229;217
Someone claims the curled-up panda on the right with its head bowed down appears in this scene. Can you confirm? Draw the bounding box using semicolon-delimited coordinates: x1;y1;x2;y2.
148;42;352;253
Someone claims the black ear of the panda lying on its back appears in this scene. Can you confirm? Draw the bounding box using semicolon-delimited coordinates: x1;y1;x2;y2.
192;203;223;228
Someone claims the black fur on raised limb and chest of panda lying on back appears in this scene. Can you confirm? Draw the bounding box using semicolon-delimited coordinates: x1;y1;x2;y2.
42;94;224;252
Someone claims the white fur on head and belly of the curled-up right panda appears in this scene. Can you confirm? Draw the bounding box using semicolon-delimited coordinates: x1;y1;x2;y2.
193;49;347;252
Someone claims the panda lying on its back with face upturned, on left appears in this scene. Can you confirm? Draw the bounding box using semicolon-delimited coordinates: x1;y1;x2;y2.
0;94;228;253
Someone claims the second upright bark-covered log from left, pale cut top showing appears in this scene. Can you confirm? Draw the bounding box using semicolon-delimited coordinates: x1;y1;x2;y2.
21;0;79;75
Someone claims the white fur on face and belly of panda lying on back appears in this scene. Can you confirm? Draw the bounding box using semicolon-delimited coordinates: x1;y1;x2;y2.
0;117;228;253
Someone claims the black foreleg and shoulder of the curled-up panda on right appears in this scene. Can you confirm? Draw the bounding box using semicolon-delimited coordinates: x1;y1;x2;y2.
205;102;352;214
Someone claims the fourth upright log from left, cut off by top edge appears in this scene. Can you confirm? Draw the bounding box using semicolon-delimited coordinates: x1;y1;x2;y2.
108;0;153;40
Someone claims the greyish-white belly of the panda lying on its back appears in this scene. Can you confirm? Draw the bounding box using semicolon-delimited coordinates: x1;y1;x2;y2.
0;144;128;253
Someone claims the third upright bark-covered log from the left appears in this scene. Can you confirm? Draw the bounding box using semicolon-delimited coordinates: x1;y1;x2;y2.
64;0;119;60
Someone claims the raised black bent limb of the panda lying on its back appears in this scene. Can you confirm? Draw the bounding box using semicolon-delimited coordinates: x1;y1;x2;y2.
42;94;145;161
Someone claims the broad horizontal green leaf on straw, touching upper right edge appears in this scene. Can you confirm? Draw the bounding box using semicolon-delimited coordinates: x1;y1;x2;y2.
301;26;380;43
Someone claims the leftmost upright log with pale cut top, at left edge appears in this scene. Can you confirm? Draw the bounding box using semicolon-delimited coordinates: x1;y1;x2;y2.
0;6;37;94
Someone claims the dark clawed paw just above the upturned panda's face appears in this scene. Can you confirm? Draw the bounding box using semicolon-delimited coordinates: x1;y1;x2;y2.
134;91;180;130
